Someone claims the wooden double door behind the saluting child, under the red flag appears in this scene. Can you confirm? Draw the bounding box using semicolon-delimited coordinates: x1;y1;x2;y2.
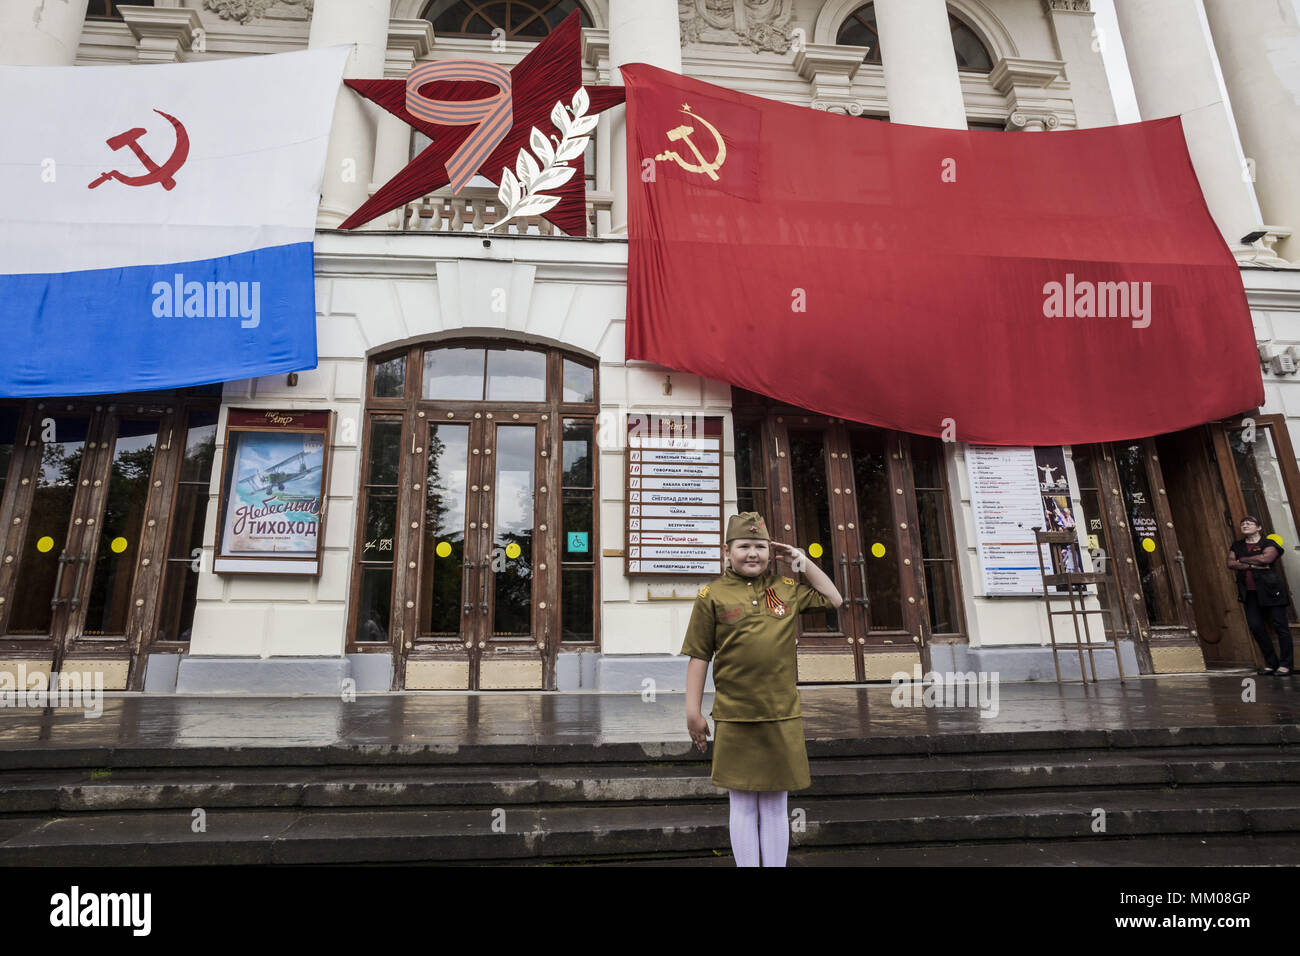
738;414;965;683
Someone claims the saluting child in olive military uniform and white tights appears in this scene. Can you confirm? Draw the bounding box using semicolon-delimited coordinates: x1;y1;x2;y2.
681;511;844;866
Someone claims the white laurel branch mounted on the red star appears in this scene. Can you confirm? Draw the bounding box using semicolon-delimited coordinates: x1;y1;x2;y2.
480;86;601;233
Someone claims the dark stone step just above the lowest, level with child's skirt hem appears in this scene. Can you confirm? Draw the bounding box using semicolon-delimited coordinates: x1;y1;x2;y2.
0;747;1300;814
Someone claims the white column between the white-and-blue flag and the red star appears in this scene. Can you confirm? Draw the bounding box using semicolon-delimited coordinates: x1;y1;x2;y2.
307;0;389;229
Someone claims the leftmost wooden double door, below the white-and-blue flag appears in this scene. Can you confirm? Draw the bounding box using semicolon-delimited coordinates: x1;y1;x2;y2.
0;397;216;689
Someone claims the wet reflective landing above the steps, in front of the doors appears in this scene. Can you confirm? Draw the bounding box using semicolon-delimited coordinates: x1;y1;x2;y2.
0;671;1300;761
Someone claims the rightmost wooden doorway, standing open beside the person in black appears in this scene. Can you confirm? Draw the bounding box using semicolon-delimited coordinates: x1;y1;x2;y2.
1073;415;1300;674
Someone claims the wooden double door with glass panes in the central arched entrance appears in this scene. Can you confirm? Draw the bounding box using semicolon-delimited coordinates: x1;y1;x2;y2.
382;406;556;689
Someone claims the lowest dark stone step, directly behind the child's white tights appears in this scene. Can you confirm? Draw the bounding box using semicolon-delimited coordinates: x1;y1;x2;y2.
0;786;1300;866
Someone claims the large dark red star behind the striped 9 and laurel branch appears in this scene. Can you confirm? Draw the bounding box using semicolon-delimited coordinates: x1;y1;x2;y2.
339;10;624;235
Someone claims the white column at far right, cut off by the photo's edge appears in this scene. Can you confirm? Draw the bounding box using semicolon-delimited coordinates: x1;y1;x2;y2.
1205;0;1300;261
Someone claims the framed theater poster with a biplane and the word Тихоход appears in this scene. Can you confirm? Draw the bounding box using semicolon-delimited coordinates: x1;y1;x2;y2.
213;408;330;575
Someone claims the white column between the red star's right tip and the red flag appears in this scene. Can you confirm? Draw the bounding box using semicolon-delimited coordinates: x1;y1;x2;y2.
608;0;681;234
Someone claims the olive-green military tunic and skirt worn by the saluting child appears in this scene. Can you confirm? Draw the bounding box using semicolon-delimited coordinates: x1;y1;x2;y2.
681;568;832;791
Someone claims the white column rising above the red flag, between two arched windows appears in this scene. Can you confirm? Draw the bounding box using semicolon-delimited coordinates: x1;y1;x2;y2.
875;0;966;130
